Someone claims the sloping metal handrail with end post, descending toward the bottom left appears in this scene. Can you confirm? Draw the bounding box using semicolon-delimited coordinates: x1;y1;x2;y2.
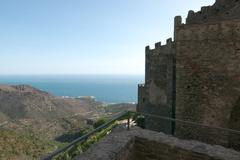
41;111;130;160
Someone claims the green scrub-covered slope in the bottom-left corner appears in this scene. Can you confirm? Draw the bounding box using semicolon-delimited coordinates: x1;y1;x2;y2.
0;129;59;160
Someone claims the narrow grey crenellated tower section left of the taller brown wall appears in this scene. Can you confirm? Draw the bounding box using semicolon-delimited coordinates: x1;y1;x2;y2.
141;39;175;133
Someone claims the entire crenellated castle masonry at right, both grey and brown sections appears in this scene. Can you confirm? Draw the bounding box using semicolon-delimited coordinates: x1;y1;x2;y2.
138;0;240;149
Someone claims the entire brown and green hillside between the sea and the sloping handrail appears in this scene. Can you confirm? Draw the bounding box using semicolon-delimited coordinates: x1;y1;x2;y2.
0;85;135;160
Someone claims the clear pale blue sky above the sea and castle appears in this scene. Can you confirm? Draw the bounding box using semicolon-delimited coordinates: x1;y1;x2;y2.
0;0;214;75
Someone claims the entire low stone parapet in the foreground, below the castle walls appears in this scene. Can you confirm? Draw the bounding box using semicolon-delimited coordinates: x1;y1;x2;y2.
74;128;240;160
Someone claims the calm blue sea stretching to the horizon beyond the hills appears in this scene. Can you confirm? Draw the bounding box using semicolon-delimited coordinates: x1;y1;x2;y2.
0;76;144;103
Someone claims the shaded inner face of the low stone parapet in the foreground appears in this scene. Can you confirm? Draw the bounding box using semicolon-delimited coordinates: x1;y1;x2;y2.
134;137;226;160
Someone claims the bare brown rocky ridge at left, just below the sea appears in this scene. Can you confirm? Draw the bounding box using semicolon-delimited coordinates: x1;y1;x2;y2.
0;85;98;120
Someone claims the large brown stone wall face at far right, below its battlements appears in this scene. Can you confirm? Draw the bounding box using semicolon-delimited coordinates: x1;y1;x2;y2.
176;17;240;149
